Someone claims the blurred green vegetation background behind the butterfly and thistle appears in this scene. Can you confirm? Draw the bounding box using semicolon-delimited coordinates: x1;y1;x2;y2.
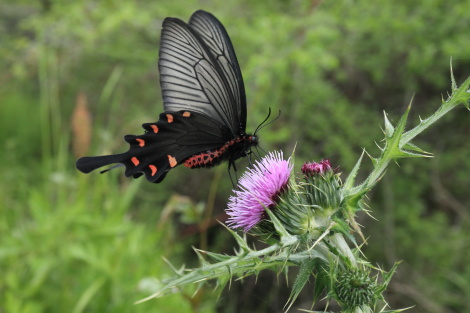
0;0;470;313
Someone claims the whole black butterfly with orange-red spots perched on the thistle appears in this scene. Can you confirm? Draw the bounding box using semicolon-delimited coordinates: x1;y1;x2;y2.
76;10;259;183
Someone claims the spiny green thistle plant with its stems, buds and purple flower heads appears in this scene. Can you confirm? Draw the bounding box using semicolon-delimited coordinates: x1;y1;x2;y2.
140;75;470;313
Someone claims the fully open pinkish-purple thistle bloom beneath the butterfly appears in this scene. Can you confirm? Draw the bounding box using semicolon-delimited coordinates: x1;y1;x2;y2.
226;151;292;232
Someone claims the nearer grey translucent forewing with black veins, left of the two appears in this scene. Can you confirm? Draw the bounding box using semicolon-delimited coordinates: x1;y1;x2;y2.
159;18;238;135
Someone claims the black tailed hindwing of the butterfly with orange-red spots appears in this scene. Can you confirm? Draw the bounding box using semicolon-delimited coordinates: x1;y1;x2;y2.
77;111;228;182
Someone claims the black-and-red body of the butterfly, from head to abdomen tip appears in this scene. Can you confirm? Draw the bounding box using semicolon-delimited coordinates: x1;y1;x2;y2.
183;135;258;168
